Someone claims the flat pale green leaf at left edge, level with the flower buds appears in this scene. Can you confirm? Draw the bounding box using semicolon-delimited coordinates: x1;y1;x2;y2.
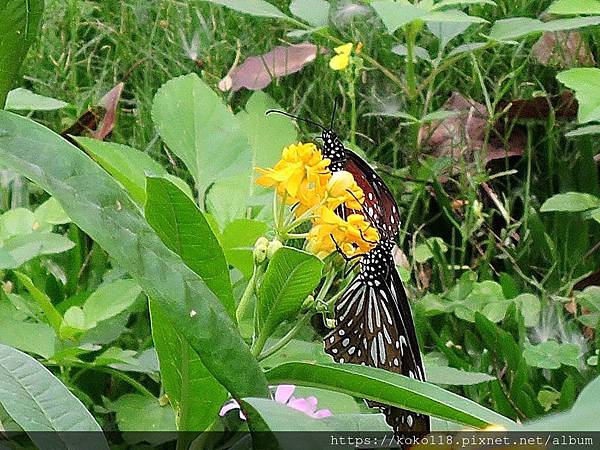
0;232;75;269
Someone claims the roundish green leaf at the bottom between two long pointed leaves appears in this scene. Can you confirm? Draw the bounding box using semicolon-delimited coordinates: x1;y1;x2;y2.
111;394;175;445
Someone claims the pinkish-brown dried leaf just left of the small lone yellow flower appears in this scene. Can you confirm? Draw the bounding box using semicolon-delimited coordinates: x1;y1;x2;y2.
219;42;325;92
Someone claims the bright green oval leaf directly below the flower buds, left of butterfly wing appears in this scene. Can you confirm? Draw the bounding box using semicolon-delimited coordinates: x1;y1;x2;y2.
258;247;323;337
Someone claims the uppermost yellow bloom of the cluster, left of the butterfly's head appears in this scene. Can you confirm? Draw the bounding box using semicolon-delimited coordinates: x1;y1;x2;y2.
256;142;331;199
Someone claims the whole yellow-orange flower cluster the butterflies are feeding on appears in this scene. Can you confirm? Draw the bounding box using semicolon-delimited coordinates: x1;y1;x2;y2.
256;143;379;258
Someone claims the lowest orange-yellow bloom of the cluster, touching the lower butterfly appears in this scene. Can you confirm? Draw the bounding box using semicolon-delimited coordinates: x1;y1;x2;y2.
306;206;379;258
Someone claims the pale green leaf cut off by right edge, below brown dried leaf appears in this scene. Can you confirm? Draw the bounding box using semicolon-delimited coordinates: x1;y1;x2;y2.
556;67;600;123
